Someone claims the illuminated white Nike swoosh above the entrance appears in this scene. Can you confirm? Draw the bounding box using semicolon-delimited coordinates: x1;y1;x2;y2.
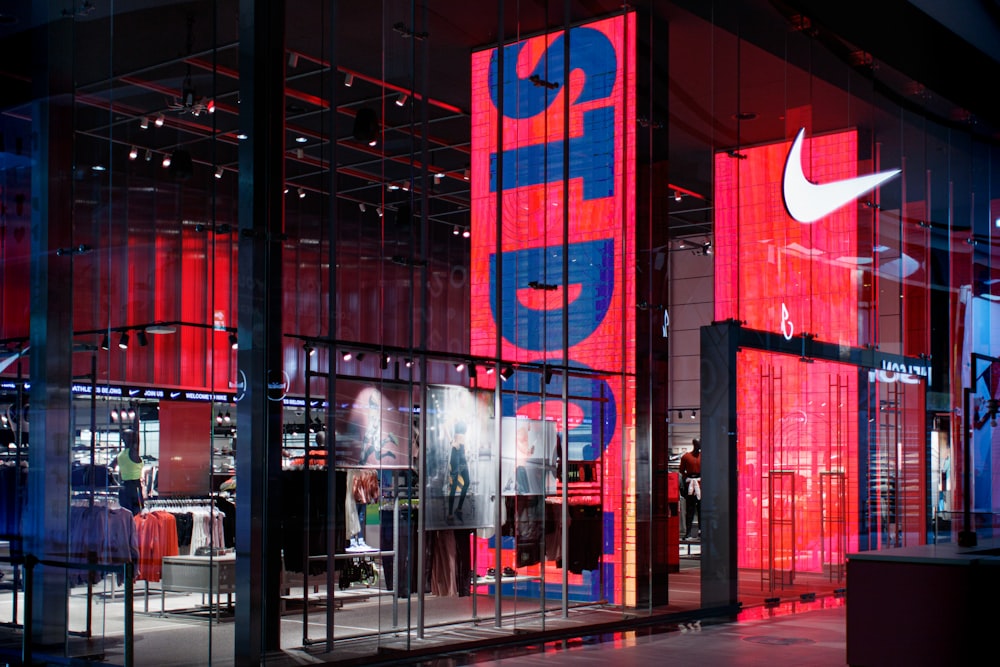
781;128;901;222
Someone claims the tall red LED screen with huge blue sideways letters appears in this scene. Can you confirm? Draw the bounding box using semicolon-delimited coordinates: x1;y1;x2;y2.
471;14;635;602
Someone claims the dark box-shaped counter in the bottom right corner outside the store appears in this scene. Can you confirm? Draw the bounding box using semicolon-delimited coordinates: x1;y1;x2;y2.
847;540;1000;666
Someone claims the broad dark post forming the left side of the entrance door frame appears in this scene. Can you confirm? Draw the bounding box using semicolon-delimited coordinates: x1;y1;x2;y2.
701;320;740;609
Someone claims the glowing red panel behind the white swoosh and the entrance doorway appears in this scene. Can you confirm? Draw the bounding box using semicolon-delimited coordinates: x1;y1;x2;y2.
715;131;865;576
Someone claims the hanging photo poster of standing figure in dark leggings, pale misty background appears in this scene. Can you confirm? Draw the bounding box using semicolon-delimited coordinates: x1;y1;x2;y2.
423;387;497;530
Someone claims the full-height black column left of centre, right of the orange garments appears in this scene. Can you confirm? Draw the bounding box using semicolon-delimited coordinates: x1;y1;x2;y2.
235;0;285;665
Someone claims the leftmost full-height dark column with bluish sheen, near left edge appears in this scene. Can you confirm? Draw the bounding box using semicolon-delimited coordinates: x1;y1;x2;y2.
24;3;74;651
